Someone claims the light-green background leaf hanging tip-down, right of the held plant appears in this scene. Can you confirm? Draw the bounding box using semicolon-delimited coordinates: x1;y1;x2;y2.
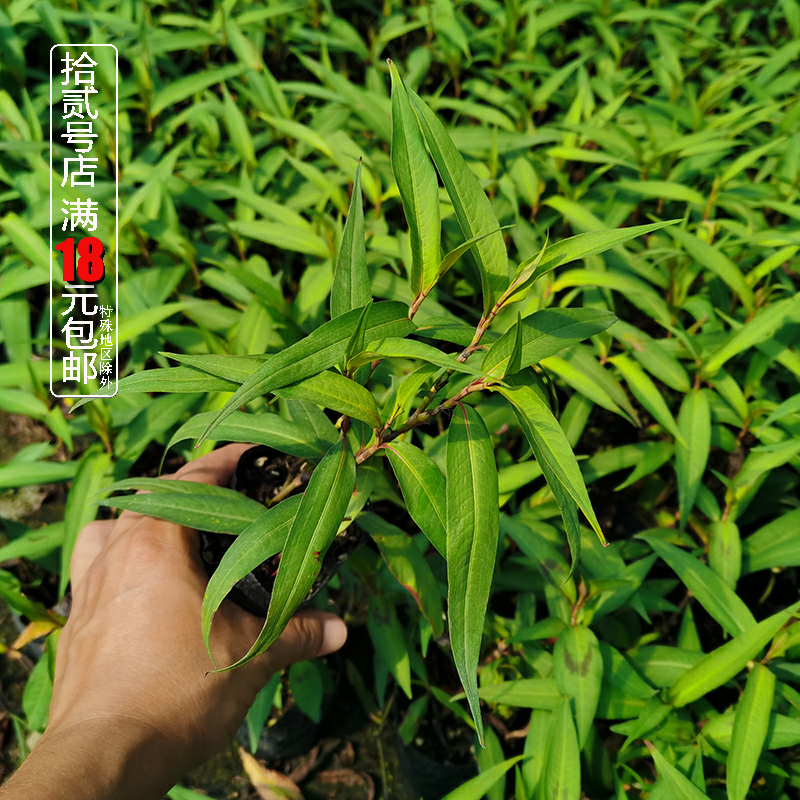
675;389;711;530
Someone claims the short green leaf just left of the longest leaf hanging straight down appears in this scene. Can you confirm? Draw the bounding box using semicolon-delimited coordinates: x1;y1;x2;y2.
383;441;447;556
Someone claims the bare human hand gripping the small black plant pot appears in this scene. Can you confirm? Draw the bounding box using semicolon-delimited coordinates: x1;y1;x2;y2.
2;445;347;797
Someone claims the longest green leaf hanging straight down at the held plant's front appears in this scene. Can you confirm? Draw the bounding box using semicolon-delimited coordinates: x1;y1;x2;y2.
447;404;500;743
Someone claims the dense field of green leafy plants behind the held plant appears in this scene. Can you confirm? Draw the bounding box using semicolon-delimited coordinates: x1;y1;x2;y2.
0;0;800;800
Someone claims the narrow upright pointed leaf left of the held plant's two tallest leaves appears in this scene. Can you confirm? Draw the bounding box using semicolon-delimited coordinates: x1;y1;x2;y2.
331;159;372;319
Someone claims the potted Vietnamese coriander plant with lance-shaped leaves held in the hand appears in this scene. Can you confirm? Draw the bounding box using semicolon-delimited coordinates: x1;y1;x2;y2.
89;63;672;743
